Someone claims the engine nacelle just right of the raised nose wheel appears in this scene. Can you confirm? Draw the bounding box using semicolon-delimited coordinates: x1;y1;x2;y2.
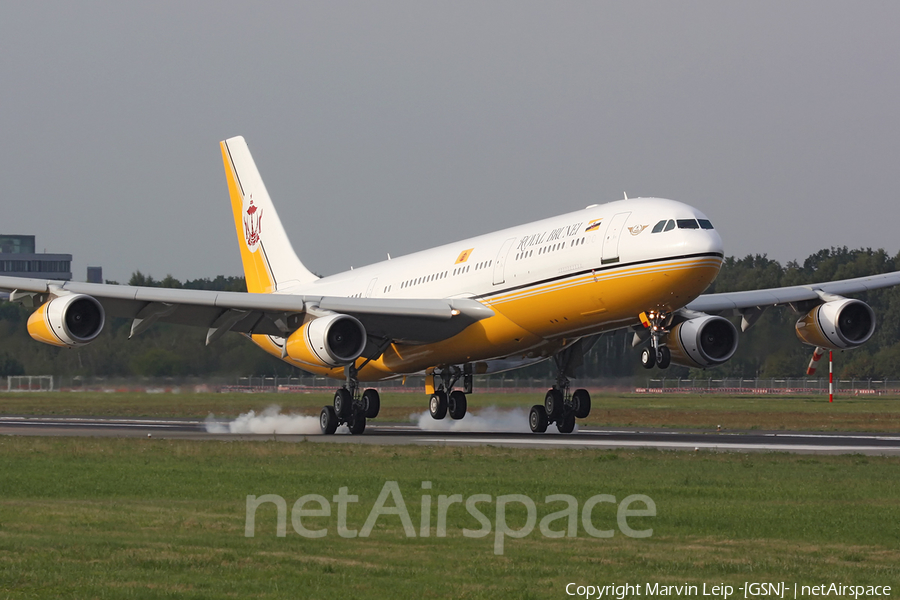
667;315;738;369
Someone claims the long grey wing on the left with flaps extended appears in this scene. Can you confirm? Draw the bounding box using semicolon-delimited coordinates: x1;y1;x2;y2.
0;277;494;344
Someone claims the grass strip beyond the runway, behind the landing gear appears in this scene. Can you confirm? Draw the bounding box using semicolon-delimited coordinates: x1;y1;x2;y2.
0;392;900;432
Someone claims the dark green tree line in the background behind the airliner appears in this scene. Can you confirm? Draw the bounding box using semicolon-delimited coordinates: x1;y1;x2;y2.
0;247;900;379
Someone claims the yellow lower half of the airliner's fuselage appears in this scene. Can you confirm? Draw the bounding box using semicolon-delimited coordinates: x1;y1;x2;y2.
253;257;722;381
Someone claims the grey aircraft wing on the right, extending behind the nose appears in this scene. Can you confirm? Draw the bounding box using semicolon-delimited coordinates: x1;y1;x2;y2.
685;271;900;314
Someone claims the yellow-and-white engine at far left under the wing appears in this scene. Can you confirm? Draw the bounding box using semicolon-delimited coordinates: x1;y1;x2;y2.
28;294;106;348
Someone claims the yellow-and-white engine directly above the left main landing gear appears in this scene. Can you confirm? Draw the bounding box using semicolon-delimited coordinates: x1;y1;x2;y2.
286;313;366;367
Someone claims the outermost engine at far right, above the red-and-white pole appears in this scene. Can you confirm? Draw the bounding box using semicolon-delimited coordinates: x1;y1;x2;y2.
794;298;875;350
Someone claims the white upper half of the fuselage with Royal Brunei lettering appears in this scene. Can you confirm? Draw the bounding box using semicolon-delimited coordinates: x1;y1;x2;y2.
290;198;723;302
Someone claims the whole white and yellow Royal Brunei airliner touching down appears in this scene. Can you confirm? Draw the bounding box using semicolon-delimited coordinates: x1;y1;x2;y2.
0;137;900;434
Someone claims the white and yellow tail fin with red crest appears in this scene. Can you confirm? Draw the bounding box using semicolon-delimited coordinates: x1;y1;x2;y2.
220;137;318;293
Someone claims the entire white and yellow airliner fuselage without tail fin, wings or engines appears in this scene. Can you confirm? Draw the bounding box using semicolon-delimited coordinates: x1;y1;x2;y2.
257;198;723;379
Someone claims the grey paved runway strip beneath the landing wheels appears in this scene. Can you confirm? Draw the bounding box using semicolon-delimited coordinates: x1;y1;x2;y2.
0;416;900;456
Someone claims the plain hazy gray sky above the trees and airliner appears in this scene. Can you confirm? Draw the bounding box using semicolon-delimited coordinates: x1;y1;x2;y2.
0;0;900;282
